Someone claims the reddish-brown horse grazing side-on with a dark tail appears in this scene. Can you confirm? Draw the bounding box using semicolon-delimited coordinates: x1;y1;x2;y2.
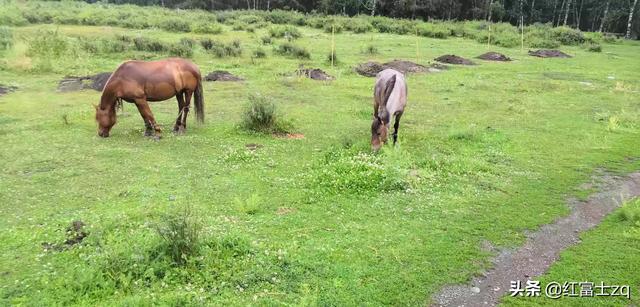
95;58;204;138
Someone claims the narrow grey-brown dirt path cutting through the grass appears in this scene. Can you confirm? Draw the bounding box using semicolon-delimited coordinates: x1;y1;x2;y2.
432;172;640;307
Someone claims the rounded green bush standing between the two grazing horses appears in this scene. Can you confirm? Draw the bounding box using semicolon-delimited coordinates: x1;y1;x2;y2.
241;94;289;133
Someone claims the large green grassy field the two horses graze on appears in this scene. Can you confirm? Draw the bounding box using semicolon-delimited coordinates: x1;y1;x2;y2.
0;2;640;305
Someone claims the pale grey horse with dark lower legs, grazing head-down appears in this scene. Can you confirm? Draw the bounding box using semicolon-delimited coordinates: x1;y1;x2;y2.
371;69;407;151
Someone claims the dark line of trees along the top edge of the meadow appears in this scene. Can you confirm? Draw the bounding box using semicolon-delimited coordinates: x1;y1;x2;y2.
96;0;640;38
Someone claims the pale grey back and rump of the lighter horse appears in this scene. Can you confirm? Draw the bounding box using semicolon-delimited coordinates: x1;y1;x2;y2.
374;68;407;114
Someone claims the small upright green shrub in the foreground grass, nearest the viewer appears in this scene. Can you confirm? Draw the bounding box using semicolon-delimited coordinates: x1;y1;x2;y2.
156;210;202;265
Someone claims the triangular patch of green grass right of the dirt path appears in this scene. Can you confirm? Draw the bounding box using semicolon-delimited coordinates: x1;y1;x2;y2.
504;200;640;306
